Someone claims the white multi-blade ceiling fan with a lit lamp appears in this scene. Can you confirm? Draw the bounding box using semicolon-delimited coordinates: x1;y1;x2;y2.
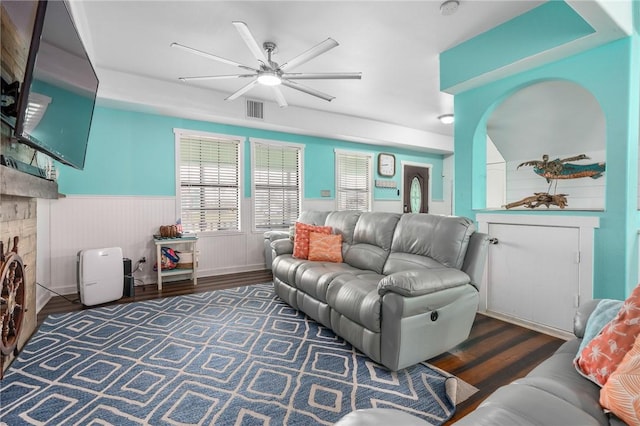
171;21;362;107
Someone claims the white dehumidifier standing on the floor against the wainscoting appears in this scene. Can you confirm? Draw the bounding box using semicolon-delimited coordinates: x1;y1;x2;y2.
77;247;124;306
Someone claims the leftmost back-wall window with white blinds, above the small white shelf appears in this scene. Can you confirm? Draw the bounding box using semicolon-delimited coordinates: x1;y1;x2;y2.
176;131;240;232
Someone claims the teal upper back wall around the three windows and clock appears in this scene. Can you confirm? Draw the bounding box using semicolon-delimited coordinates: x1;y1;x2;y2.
58;107;443;200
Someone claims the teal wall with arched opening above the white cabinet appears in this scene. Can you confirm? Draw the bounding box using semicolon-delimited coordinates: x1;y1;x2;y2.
443;5;640;298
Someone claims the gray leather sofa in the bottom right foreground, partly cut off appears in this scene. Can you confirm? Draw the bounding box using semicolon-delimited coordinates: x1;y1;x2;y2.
336;300;625;426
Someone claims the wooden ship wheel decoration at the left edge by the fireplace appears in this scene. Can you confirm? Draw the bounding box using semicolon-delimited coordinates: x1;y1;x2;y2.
0;237;25;361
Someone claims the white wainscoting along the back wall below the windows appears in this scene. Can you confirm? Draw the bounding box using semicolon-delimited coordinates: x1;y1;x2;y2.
37;195;450;302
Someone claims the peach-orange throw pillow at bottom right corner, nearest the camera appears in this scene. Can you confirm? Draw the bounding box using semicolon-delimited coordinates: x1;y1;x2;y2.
600;337;640;425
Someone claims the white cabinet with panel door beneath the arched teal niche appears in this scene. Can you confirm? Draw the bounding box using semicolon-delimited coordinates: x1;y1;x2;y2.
477;214;598;334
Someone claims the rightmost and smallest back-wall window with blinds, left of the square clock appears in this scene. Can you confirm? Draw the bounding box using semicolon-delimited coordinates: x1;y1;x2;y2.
336;151;372;211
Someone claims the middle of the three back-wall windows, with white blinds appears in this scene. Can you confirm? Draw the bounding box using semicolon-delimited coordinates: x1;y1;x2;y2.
252;140;302;230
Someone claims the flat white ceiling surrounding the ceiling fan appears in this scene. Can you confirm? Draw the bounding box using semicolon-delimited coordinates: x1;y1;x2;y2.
67;0;543;135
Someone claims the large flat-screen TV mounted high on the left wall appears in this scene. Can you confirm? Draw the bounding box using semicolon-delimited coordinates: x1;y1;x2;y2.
3;1;98;170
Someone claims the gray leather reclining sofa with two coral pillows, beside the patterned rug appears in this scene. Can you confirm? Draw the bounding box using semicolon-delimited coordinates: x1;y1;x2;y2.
270;211;488;370
